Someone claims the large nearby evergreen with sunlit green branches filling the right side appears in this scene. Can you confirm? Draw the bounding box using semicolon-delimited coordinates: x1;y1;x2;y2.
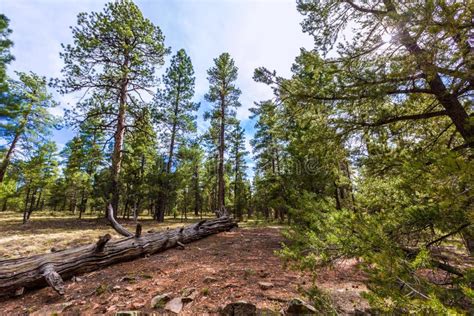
254;1;474;314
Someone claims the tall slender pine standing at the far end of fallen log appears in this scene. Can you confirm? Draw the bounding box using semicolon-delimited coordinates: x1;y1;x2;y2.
205;53;241;216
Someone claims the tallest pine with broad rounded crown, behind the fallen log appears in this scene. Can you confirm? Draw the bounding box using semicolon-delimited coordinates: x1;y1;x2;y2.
58;0;167;214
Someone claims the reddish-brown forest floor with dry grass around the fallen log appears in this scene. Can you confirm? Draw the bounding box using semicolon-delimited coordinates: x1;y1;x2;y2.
0;217;368;315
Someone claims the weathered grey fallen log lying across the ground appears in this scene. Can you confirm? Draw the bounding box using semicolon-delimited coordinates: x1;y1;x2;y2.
0;217;237;296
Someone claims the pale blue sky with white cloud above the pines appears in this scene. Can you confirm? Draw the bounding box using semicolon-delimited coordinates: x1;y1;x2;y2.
0;0;312;173
